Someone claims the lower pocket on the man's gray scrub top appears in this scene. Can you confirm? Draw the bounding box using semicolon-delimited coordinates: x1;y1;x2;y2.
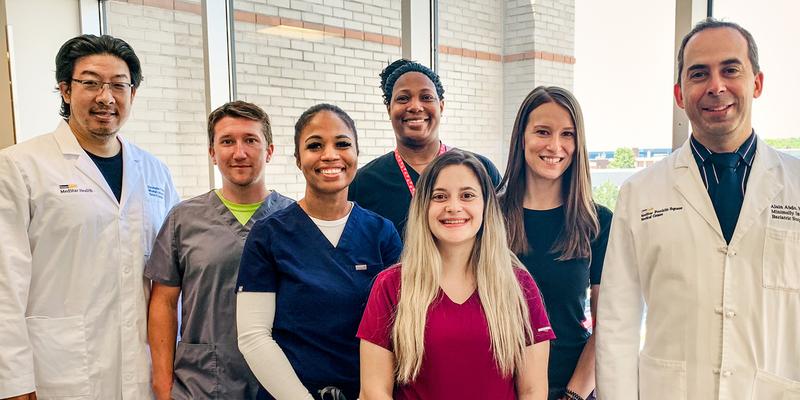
172;342;219;399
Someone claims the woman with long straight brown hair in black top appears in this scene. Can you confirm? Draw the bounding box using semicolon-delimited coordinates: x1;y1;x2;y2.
500;86;611;400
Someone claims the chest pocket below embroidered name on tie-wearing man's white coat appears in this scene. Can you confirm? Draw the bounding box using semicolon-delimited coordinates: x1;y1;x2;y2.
761;227;800;291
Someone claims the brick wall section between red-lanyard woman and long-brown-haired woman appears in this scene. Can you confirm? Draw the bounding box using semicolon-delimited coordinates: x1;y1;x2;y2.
439;0;575;170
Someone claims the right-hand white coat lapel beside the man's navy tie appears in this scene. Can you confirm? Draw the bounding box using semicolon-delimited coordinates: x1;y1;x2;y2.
731;139;783;244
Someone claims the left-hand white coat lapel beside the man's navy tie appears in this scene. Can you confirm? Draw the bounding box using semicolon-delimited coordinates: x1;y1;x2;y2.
673;139;723;238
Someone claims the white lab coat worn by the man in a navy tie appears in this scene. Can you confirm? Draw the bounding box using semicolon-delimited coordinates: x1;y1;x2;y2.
597;140;800;400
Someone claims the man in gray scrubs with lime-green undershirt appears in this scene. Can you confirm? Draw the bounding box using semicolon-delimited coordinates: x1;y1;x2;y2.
145;101;292;400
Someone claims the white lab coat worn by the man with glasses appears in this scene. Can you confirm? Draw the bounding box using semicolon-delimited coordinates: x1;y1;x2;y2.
0;123;178;400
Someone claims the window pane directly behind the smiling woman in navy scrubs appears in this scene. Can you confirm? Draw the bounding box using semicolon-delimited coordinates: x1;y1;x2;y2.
234;0;401;198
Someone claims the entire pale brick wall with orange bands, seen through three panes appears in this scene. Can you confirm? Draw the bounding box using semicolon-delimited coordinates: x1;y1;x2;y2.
109;0;575;198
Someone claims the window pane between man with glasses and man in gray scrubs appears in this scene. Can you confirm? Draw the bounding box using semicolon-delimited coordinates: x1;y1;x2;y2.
107;0;209;198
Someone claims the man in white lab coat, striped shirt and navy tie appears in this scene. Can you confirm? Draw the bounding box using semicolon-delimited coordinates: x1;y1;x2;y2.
597;19;800;400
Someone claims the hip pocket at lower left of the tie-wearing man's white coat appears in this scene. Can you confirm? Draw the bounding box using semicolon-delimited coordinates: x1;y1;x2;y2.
639;354;686;400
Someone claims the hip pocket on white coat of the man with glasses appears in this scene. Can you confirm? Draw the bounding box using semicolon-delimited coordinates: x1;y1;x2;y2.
25;315;91;398
